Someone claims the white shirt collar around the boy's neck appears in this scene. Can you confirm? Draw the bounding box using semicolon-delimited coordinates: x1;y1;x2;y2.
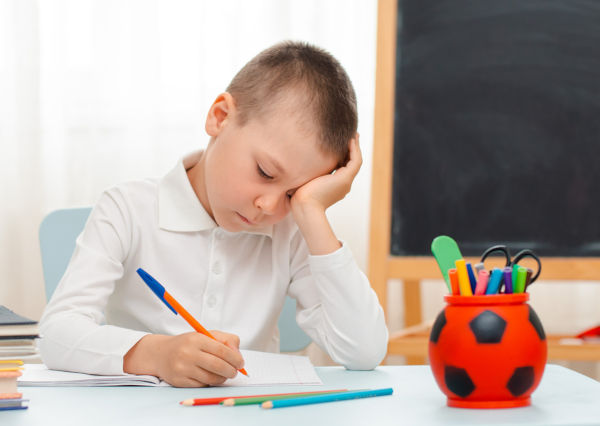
158;151;273;237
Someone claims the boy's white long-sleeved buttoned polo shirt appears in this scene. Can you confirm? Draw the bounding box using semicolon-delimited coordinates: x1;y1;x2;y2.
40;152;388;374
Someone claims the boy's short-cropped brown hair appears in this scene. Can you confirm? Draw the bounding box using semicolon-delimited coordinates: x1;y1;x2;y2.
227;41;358;164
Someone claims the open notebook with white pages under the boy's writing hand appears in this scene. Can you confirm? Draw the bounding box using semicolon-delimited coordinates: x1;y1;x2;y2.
17;350;323;386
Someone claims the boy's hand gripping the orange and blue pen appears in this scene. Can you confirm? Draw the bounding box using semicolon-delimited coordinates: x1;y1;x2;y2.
123;330;244;387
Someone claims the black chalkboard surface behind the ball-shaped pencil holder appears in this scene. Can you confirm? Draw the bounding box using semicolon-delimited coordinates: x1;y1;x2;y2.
390;0;600;257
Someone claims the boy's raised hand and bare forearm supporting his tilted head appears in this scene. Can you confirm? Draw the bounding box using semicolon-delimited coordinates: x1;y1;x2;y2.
291;133;362;255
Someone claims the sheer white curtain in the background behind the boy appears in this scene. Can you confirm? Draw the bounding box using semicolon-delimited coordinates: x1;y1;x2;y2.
0;0;377;319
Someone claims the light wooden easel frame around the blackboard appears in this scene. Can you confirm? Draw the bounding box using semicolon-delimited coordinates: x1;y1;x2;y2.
368;0;600;363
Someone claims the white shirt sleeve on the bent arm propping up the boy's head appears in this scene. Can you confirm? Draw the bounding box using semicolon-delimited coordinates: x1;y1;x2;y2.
289;236;388;370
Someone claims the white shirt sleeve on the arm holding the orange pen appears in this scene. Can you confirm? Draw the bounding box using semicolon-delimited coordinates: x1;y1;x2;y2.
39;191;146;374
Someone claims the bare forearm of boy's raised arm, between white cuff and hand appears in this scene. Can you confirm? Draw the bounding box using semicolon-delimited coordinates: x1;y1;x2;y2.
293;204;342;256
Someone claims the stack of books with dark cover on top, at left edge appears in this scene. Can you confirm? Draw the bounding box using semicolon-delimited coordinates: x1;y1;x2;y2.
0;305;39;362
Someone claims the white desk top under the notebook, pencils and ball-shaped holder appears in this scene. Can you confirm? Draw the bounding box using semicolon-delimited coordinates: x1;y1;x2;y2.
0;365;600;426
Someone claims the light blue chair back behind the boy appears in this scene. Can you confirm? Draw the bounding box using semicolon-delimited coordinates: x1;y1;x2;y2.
39;207;311;352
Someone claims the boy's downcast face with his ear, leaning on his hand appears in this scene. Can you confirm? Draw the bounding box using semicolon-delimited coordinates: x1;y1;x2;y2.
192;94;337;232
